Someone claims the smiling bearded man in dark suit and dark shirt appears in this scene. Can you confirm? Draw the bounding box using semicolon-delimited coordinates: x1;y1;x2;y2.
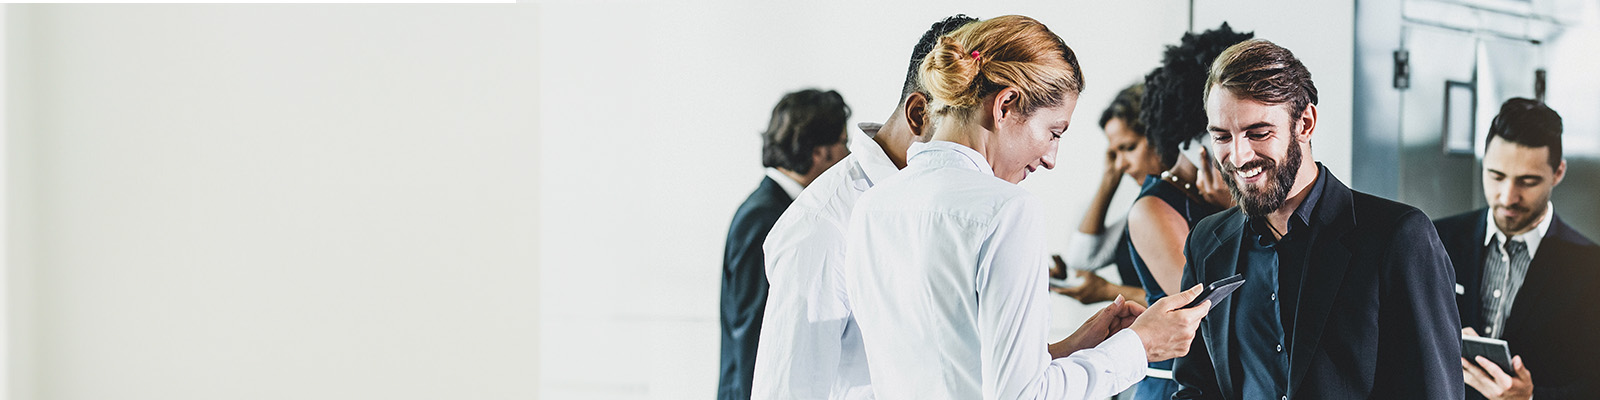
1173;38;1462;400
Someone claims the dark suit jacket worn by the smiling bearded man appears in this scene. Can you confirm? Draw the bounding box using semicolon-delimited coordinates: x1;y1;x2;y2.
1173;173;1462;400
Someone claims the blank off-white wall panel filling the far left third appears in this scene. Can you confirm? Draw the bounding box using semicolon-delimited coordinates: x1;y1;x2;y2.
6;5;541;400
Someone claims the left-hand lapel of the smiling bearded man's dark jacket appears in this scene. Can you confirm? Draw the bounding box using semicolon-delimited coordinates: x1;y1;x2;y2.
1200;211;1245;398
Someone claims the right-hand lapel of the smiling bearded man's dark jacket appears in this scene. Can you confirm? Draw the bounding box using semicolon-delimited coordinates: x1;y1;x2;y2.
1290;174;1355;397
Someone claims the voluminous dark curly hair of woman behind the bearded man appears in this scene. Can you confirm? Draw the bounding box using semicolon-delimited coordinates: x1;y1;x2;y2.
1139;22;1256;168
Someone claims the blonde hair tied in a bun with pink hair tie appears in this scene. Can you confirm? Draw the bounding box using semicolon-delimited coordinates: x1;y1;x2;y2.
922;16;1083;118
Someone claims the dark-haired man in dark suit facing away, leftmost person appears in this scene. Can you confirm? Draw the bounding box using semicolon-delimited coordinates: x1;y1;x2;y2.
717;90;850;400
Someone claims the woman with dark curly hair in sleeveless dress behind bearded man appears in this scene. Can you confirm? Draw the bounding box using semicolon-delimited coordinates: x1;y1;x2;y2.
1128;22;1254;400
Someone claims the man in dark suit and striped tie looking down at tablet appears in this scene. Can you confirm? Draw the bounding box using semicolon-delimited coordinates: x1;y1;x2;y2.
1434;99;1600;400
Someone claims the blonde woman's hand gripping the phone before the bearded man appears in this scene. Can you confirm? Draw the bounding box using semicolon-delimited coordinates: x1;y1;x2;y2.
1130;285;1211;363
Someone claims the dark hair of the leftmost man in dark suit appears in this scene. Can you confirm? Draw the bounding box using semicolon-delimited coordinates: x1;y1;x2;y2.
762;90;850;174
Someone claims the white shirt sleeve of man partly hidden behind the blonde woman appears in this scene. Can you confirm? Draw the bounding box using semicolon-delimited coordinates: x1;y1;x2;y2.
750;210;850;398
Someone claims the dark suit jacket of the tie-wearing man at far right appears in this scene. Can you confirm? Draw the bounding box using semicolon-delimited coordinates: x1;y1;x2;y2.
1434;208;1600;400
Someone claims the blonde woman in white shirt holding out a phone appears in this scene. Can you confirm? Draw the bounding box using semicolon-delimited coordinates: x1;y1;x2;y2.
845;16;1206;400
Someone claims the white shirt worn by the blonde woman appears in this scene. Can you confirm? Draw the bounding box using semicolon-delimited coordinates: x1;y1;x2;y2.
845;141;1146;400
